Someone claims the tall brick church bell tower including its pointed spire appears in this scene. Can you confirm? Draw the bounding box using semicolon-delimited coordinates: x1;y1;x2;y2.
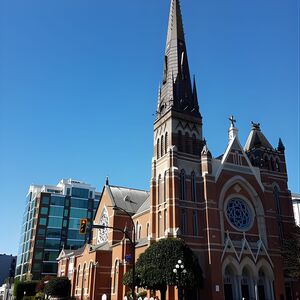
151;0;205;240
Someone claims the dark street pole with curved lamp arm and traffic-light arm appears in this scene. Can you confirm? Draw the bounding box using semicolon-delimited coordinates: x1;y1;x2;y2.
92;206;136;300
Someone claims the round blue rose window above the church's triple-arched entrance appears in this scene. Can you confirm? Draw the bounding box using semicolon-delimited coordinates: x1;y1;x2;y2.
226;198;252;230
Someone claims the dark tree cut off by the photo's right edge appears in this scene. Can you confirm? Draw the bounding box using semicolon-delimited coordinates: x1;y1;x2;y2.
283;226;300;279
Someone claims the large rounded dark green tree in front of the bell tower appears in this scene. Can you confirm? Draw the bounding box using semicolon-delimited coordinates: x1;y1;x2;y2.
123;238;202;300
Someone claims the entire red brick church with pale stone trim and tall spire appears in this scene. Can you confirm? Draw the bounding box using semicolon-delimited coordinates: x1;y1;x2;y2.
58;0;300;300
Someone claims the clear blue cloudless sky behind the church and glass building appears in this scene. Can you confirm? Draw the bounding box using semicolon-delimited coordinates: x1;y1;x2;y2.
0;0;300;254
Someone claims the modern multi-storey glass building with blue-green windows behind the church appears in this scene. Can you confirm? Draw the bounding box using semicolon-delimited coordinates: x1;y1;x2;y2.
16;179;100;279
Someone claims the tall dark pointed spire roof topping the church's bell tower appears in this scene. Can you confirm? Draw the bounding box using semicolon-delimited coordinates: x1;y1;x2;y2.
157;0;200;118
